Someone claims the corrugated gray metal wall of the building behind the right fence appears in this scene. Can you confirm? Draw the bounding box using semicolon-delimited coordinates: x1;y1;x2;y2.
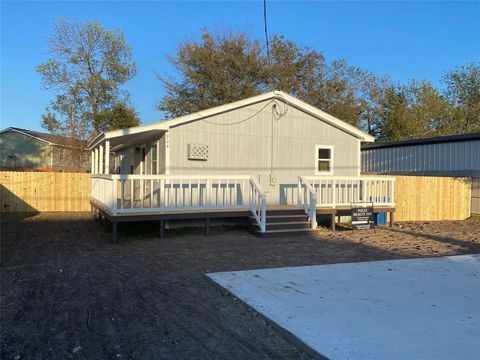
362;140;480;176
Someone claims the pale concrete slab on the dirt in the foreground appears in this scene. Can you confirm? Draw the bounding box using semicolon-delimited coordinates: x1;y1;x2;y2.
207;255;480;359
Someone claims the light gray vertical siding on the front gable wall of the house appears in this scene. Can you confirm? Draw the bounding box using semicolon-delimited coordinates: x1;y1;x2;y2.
169;102;360;203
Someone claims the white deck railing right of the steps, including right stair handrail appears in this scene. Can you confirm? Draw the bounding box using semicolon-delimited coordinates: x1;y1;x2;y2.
298;176;395;227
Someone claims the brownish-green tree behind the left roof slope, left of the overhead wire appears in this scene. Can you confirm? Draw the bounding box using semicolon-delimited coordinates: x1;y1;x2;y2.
157;30;267;117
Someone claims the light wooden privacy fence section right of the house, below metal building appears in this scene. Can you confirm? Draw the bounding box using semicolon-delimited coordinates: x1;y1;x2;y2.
395;176;471;221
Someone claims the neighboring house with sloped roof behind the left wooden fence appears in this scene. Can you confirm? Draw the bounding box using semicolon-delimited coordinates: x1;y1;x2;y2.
0;127;90;172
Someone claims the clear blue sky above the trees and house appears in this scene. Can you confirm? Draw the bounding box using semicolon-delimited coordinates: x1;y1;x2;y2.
0;1;480;130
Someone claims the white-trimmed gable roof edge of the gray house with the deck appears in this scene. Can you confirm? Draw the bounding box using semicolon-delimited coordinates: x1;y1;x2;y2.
89;91;375;148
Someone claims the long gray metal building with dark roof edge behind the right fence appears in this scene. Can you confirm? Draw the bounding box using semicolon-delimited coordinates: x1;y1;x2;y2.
362;133;480;214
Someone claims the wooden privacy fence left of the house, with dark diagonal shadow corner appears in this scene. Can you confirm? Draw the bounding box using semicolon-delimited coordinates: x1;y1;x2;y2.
0;171;91;212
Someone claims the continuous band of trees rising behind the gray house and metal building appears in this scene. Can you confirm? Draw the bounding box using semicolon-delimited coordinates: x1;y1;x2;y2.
158;30;480;141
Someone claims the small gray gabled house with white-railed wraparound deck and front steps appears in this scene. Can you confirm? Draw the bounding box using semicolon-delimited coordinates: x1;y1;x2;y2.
90;91;395;237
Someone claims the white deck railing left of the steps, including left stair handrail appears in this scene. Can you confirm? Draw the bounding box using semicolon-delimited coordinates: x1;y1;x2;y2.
92;174;266;231
